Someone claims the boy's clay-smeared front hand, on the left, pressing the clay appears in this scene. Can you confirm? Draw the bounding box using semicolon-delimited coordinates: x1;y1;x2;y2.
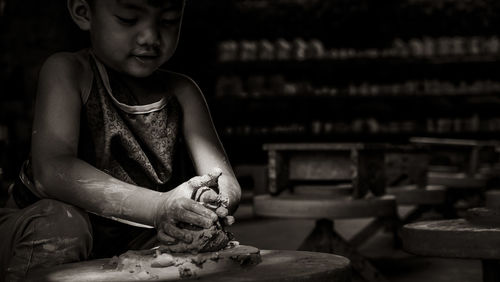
154;169;221;244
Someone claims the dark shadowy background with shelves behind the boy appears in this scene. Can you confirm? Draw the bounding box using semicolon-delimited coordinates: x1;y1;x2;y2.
0;0;500;182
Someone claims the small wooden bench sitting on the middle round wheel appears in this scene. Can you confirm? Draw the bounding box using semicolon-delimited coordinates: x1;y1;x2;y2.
264;143;387;198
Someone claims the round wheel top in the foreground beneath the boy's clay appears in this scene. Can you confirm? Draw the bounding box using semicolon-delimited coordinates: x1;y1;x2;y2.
27;246;351;282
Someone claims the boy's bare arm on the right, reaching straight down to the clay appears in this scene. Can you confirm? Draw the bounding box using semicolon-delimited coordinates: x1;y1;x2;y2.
176;76;241;213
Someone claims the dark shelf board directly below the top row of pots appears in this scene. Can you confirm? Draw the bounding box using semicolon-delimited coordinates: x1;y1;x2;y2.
215;56;500;80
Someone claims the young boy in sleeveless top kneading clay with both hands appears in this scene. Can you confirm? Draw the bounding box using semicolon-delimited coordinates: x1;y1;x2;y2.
0;0;241;281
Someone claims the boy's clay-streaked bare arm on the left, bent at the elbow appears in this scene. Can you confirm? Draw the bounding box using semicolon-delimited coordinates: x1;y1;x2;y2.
32;54;217;238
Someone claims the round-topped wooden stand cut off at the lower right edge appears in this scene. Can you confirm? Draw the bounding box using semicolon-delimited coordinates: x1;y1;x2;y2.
401;219;500;282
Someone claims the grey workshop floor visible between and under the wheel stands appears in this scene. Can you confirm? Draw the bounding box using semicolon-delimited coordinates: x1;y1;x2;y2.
231;204;482;282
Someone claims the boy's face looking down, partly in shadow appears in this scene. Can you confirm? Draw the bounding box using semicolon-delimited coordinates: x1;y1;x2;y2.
90;0;183;77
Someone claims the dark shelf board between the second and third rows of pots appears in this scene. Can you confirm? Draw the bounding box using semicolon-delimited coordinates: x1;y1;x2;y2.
211;93;500;121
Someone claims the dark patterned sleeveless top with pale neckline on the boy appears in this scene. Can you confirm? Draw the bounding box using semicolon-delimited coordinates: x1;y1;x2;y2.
16;51;182;206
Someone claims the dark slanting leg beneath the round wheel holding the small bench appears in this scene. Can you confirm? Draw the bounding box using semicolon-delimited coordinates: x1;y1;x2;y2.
299;219;388;282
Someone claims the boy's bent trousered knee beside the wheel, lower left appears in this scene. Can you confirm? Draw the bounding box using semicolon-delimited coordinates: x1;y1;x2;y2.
8;199;92;275
